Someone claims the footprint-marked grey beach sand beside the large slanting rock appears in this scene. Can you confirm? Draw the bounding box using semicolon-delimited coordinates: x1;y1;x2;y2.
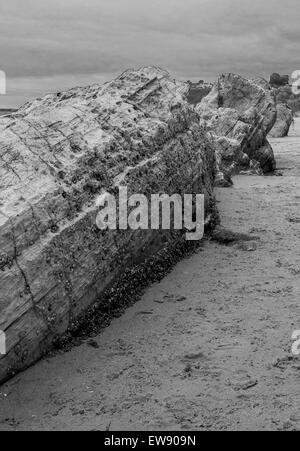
0;119;300;431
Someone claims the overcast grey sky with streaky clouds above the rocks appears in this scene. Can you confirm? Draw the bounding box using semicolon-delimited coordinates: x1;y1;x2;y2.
0;0;300;106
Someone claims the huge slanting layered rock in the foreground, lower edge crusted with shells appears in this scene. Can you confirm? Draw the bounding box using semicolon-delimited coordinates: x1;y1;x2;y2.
0;67;215;381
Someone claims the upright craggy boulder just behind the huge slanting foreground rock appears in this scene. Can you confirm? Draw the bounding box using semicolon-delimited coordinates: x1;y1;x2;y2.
196;74;276;174
